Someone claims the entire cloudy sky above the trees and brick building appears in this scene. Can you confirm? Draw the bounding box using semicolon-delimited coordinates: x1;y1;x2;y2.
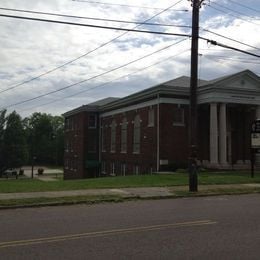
0;0;260;116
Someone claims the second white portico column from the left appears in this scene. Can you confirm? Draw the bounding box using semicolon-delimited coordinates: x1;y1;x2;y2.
219;103;227;165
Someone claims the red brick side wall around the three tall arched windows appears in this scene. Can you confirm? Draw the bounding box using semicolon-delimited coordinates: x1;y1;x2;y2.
102;106;157;175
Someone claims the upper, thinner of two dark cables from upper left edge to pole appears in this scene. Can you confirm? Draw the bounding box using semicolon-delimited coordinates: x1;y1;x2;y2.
0;7;191;28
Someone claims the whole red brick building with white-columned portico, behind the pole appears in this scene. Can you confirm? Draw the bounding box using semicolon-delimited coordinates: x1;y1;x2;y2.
64;70;260;179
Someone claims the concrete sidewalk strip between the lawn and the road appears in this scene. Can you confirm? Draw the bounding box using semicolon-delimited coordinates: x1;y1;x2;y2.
0;183;260;200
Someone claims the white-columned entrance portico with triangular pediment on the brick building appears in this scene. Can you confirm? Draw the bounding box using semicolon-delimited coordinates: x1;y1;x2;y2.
198;71;260;169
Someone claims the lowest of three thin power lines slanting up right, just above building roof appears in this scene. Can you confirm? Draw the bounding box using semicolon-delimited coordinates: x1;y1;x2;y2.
19;49;190;112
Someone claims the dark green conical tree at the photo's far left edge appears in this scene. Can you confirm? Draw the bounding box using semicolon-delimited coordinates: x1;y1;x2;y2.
3;111;28;168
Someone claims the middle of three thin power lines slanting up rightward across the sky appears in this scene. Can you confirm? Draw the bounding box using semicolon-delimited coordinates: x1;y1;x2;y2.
0;39;186;109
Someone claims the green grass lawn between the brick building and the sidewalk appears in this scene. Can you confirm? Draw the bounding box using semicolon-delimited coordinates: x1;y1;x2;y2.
0;171;260;193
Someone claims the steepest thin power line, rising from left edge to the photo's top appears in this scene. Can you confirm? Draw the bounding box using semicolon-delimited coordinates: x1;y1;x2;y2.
0;0;186;93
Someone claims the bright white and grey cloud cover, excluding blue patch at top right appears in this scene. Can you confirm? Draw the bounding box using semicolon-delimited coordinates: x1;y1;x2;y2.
0;0;260;116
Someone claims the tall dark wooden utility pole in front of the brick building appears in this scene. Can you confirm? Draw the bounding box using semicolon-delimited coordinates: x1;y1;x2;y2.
189;0;203;192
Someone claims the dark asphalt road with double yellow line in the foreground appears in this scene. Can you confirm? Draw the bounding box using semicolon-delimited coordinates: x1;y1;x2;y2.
0;195;260;260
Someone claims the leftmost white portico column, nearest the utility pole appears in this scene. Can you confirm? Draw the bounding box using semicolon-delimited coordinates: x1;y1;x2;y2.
210;103;218;165
